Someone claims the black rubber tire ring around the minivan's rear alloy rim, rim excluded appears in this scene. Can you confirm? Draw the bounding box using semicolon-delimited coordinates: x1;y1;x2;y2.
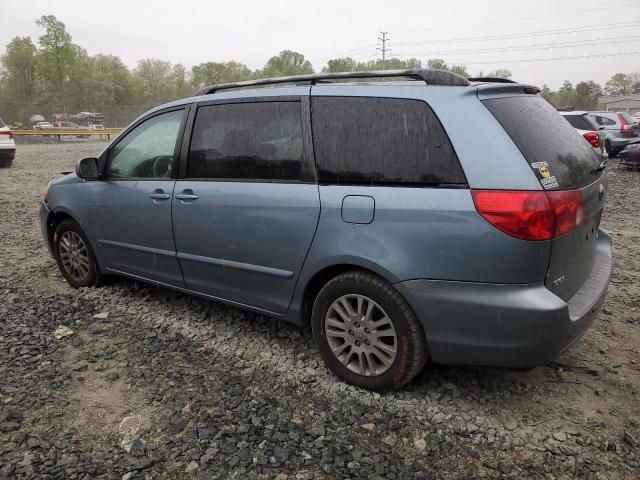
311;271;428;390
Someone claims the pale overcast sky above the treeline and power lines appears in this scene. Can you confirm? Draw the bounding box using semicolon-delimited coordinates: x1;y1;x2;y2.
0;0;640;89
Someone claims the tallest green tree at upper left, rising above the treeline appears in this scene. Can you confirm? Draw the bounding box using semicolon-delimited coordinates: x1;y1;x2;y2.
36;15;79;103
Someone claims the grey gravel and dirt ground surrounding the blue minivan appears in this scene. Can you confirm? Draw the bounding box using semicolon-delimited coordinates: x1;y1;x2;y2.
0;142;640;480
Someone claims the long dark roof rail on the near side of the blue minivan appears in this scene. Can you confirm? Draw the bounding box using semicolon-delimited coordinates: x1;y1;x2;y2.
193;69;469;97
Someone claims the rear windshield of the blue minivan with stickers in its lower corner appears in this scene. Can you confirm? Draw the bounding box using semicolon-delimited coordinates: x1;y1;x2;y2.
482;95;600;190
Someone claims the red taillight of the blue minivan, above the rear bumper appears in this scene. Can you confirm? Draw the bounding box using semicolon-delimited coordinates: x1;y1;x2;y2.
471;190;585;240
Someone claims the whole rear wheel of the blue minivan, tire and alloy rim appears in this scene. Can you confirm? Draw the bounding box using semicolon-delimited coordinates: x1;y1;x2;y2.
312;271;428;390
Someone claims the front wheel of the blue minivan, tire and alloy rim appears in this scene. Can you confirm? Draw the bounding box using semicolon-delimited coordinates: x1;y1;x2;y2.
53;219;102;288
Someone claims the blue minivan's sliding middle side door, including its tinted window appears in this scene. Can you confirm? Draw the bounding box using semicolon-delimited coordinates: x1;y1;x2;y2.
173;99;320;313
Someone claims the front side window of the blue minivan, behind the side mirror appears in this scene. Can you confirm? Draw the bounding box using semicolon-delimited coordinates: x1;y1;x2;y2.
107;110;184;179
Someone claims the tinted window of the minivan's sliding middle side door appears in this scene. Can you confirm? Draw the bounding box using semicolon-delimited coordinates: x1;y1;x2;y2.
187;102;309;181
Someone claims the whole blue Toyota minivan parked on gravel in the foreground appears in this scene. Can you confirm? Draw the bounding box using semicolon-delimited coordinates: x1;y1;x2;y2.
40;70;611;390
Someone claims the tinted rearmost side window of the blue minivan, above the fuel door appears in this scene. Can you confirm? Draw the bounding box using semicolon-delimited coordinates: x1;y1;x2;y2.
312;97;466;185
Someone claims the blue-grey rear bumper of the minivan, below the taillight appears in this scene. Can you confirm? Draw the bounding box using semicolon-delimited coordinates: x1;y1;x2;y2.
396;231;612;368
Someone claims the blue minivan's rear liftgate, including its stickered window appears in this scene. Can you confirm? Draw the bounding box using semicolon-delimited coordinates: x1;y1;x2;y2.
481;94;606;301
